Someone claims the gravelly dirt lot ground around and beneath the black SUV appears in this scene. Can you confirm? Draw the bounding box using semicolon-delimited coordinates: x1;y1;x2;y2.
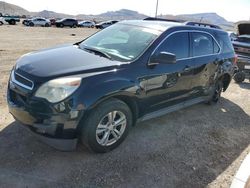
0;26;250;188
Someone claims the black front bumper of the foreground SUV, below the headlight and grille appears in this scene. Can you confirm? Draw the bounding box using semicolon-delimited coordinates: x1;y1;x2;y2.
7;83;83;151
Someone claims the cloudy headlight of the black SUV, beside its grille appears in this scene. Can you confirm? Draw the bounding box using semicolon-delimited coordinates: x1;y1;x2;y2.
35;78;81;103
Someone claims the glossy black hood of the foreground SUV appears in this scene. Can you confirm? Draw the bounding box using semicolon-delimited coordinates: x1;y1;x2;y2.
16;45;121;77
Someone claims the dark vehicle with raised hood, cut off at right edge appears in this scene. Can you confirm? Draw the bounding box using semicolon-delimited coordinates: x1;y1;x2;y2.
233;22;250;83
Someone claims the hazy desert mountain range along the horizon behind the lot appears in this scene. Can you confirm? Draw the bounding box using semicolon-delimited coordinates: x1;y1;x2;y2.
0;1;233;27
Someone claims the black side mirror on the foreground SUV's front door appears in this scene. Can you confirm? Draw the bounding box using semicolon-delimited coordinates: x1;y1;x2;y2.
149;52;176;65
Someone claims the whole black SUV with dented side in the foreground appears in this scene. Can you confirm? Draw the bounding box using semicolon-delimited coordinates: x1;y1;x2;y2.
7;21;235;152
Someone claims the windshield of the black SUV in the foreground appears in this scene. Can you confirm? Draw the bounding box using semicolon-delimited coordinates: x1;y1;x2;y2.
80;24;161;61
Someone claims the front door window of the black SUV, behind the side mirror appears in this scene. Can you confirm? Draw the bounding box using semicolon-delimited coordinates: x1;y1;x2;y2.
157;32;189;59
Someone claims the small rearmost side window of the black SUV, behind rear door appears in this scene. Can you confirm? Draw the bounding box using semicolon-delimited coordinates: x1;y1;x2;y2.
217;33;234;53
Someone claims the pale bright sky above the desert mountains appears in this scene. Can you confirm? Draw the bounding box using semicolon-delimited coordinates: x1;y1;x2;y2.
5;0;250;21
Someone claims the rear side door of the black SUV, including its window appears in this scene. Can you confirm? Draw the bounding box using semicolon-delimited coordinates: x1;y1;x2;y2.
191;31;220;96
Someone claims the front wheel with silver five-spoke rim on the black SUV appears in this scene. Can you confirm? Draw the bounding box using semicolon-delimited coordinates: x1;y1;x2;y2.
81;99;133;153
